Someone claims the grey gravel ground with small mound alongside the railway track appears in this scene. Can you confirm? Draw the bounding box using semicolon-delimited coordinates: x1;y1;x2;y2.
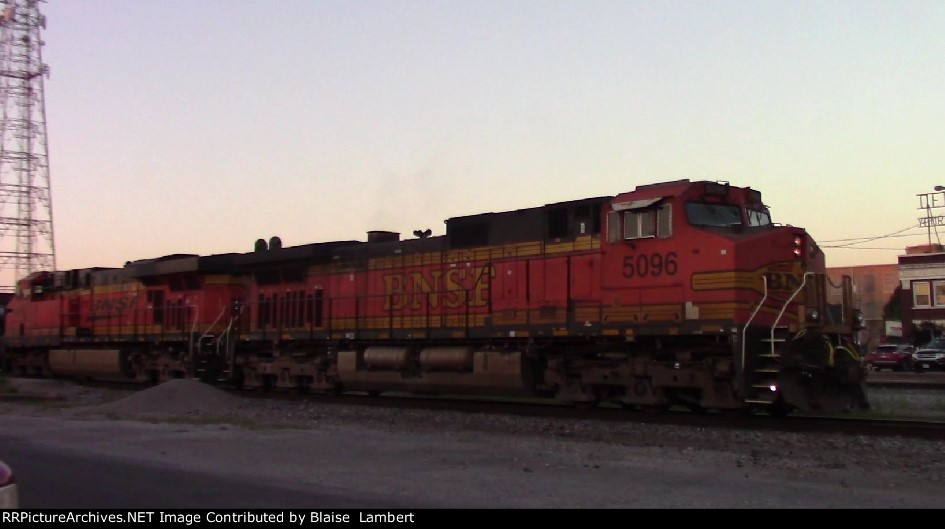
0;380;945;508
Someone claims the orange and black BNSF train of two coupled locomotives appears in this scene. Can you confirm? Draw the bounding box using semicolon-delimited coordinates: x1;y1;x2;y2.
3;180;868;414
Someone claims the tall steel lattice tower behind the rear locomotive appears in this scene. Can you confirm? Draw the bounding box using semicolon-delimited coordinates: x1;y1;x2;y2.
0;0;56;292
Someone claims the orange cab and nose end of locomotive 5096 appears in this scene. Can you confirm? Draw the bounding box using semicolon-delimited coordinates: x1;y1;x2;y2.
602;180;868;413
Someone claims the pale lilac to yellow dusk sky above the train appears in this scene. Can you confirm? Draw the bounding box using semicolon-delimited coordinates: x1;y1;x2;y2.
20;0;945;269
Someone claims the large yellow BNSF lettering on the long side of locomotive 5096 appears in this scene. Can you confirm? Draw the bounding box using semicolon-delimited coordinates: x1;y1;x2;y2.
383;266;495;310
